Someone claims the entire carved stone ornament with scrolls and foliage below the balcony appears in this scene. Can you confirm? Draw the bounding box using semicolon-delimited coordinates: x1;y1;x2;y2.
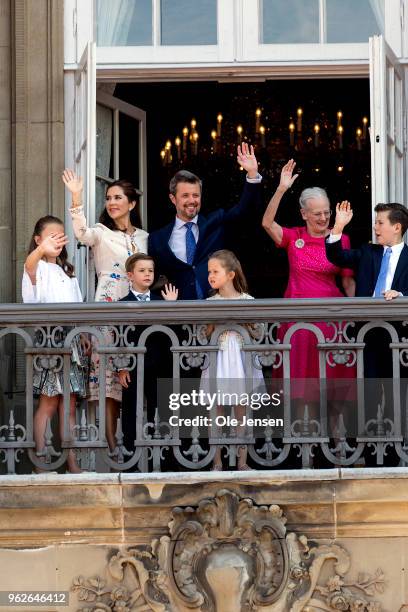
72;489;385;612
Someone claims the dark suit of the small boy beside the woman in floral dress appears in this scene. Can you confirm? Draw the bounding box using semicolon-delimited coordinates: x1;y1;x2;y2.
119;291;172;450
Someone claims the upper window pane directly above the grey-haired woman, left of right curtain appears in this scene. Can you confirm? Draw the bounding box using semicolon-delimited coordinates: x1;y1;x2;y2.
261;0;319;44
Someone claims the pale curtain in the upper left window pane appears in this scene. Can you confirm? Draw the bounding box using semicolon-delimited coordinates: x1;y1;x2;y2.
96;0;136;47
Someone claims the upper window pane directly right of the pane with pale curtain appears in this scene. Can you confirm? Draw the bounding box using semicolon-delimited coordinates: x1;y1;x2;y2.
161;0;217;45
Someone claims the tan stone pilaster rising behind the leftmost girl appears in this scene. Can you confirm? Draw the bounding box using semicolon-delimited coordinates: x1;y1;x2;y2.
11;0;64;301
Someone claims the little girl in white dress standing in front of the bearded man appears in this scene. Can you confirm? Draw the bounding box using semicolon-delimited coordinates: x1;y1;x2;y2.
201;249;263;471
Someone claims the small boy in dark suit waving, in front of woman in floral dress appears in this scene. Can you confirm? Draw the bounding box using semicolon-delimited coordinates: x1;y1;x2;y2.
118;253;178;450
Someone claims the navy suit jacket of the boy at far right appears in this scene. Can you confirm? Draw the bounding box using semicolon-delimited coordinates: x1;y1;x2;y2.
326;239;408;297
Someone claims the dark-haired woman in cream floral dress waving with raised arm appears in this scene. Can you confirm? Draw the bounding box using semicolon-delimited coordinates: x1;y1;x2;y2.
62;170;148;449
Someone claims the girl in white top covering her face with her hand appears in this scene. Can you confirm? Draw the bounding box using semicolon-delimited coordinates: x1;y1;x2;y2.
22;215;86;472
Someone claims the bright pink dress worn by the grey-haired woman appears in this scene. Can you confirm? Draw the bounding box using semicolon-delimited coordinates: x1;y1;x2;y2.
277;227;356;401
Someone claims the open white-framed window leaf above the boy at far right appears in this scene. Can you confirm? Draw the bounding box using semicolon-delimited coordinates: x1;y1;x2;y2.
370;36;407;232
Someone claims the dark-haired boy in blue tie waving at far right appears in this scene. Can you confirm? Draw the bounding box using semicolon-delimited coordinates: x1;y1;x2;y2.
326;201;408;378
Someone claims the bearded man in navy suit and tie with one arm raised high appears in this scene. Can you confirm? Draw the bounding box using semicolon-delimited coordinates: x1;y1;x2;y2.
148;143;262;300
